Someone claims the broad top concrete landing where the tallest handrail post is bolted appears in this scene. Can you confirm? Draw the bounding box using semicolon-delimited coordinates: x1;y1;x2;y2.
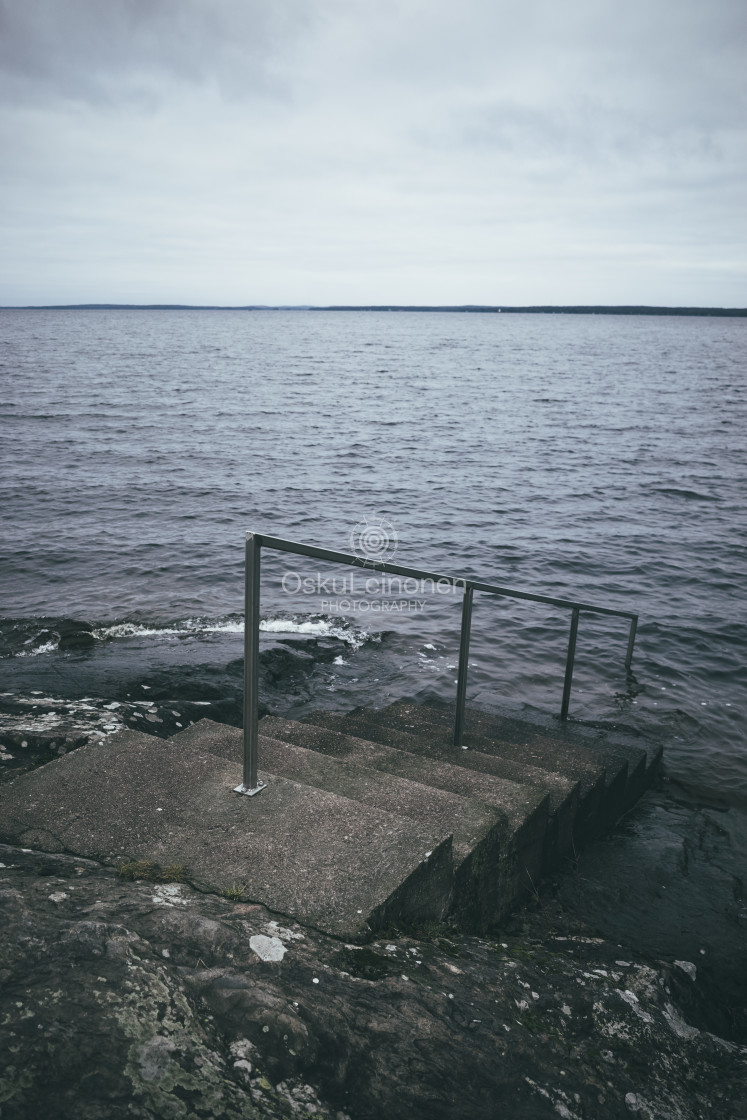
0;730;454;940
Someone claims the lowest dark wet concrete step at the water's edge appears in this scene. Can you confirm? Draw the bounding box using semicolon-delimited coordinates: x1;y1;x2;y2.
379;701;661;818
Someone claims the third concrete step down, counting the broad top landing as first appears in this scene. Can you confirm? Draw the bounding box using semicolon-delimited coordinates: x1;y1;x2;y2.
260;716;549;930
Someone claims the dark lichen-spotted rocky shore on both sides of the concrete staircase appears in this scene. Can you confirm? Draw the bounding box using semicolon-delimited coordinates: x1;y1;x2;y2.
0;689;747;1120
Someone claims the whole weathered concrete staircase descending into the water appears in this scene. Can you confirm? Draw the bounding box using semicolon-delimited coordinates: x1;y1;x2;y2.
0;703;661;940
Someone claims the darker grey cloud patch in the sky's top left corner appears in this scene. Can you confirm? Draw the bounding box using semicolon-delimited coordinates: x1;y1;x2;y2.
0;0;309;103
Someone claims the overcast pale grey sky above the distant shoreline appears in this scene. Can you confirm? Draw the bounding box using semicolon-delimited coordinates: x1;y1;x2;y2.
0;0;747;307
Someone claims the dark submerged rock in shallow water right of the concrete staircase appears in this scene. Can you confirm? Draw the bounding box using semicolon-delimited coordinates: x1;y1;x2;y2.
558;788;747;1040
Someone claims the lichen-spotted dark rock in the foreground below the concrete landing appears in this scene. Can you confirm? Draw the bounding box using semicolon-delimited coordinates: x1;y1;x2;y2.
0;848;747;1120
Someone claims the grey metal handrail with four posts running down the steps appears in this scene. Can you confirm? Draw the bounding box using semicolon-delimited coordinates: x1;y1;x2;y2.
235;533;638;796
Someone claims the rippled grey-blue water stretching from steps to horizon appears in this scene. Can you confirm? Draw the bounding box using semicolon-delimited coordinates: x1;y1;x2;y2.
0;309;747;808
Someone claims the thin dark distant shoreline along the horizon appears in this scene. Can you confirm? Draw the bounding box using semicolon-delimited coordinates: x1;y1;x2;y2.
0;304;747;318
